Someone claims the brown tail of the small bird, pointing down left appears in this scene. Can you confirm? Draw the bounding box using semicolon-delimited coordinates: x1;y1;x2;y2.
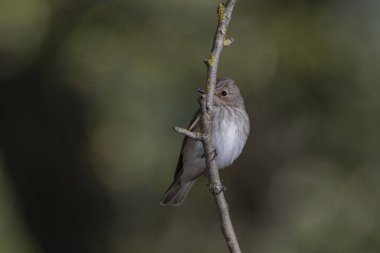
160;177;195;206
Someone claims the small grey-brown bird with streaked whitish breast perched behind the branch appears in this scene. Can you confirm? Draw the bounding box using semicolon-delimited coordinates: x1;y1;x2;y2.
160;77;250;206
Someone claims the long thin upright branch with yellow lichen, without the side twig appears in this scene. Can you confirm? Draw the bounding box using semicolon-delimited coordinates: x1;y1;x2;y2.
201;0;241;253
